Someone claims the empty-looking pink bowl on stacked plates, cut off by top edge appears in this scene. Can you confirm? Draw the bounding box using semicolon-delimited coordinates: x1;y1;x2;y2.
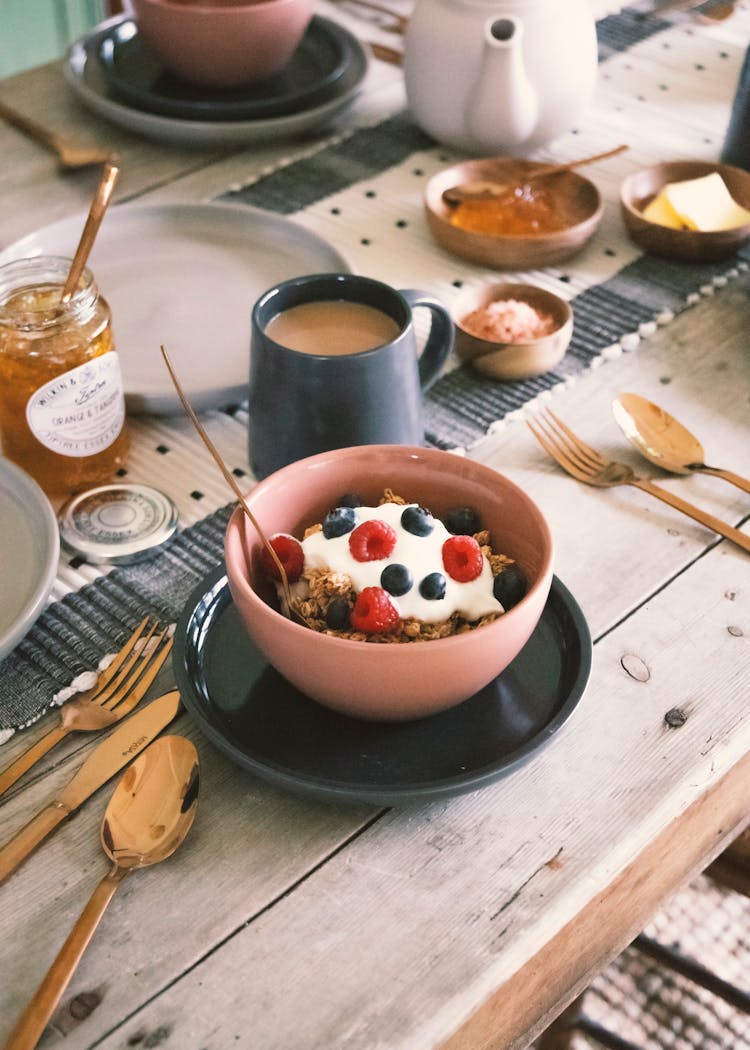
130;0;315;87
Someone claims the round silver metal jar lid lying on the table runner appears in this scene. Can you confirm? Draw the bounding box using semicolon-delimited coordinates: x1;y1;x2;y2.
58;484;178;565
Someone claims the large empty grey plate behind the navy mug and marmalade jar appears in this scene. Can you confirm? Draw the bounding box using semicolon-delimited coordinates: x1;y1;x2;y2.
0;204;350;415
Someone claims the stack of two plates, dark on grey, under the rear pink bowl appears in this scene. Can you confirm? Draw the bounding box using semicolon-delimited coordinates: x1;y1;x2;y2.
65;15;368;146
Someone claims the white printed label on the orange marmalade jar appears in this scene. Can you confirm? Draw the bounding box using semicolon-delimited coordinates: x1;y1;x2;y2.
26;350;125;457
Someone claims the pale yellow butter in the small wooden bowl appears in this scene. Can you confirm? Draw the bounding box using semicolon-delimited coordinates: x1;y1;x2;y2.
643;171;750;232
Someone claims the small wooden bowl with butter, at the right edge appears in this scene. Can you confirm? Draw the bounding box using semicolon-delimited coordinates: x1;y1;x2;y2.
620;161;750;263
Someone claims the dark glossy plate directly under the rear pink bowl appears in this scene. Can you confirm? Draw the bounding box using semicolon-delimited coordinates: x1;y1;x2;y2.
91;16;361;121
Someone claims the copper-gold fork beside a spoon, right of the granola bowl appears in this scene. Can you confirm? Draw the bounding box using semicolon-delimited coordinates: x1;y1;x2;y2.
526;408;750;553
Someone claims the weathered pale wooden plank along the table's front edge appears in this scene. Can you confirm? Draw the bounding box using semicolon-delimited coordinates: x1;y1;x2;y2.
77;551;750;1050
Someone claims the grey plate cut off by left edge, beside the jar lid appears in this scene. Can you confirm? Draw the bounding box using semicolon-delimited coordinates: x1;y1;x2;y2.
0;457;60;659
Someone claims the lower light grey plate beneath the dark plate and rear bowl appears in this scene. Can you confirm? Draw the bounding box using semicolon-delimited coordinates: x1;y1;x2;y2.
63;18;369;147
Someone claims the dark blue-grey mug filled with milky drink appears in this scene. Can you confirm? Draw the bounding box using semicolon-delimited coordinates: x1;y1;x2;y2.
249;274;454;478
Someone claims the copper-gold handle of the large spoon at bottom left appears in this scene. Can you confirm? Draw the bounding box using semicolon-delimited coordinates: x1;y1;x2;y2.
5;867;128;1050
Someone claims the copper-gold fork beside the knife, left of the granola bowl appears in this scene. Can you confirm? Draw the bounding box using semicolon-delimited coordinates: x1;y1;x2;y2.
0;617;172;795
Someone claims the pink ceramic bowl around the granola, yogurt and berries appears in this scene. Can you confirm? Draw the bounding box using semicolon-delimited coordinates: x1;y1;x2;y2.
225;445;553;721
